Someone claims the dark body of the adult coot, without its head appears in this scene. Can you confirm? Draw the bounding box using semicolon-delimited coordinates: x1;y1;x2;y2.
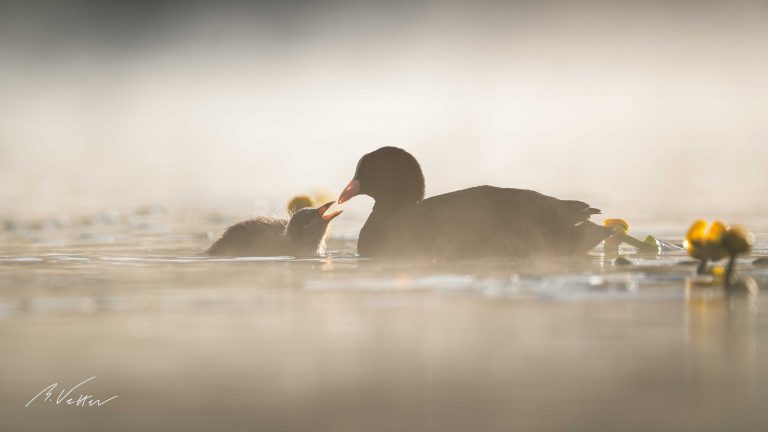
358;186;610;258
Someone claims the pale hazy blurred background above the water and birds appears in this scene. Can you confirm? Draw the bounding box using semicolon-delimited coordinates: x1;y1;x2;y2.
0;1;768;221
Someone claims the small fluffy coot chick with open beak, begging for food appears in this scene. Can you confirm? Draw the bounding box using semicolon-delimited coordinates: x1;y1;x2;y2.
206;201;341;256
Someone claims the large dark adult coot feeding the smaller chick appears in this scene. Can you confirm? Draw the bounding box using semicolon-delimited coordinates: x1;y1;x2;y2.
338;147;612;259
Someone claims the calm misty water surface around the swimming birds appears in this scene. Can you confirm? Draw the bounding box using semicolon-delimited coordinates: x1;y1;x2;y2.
0;208;768;431
